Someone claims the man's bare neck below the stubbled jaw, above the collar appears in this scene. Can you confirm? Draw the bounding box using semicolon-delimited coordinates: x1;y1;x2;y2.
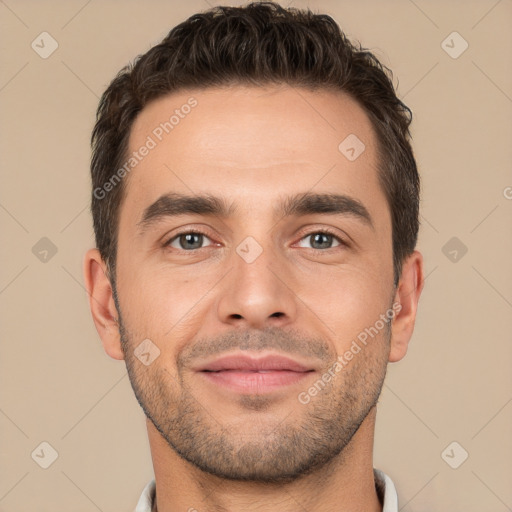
146;408;382;512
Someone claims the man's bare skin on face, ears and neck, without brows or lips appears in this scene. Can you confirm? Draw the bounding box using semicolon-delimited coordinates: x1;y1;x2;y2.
84;85;423;512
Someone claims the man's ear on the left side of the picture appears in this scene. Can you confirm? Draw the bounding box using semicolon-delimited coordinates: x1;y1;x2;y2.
84;249;124;360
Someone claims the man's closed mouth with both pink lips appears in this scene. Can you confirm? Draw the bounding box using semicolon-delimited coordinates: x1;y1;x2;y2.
197;354;315;394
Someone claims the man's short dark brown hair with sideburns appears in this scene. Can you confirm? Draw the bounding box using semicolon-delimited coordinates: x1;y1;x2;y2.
91;2;420;284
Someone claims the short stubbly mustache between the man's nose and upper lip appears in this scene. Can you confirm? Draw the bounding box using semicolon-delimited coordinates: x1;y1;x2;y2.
177;327;336;367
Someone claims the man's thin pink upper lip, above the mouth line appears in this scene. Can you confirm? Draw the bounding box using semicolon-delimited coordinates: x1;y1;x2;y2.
197;354;313;372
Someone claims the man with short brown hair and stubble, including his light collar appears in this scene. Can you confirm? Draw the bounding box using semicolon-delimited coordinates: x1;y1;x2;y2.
84;2;423;512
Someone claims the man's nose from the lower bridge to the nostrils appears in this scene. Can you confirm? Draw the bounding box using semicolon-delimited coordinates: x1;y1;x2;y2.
218;238;299;329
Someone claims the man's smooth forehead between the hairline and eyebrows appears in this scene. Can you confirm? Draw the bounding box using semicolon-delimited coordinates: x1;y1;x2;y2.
125;85;383;221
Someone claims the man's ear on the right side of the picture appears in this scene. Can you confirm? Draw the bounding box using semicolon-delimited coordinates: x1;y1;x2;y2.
389;251;424;363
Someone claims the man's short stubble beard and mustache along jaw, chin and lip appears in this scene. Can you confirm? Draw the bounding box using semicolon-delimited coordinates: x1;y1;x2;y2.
116;288;391;484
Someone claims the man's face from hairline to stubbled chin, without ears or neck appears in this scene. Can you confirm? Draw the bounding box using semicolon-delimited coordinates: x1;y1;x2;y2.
116;86;394;482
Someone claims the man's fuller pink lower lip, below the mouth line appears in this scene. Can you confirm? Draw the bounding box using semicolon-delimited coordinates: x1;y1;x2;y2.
200;370;313;393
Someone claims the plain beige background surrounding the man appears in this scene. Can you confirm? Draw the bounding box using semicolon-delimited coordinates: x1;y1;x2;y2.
0;0;512;512
